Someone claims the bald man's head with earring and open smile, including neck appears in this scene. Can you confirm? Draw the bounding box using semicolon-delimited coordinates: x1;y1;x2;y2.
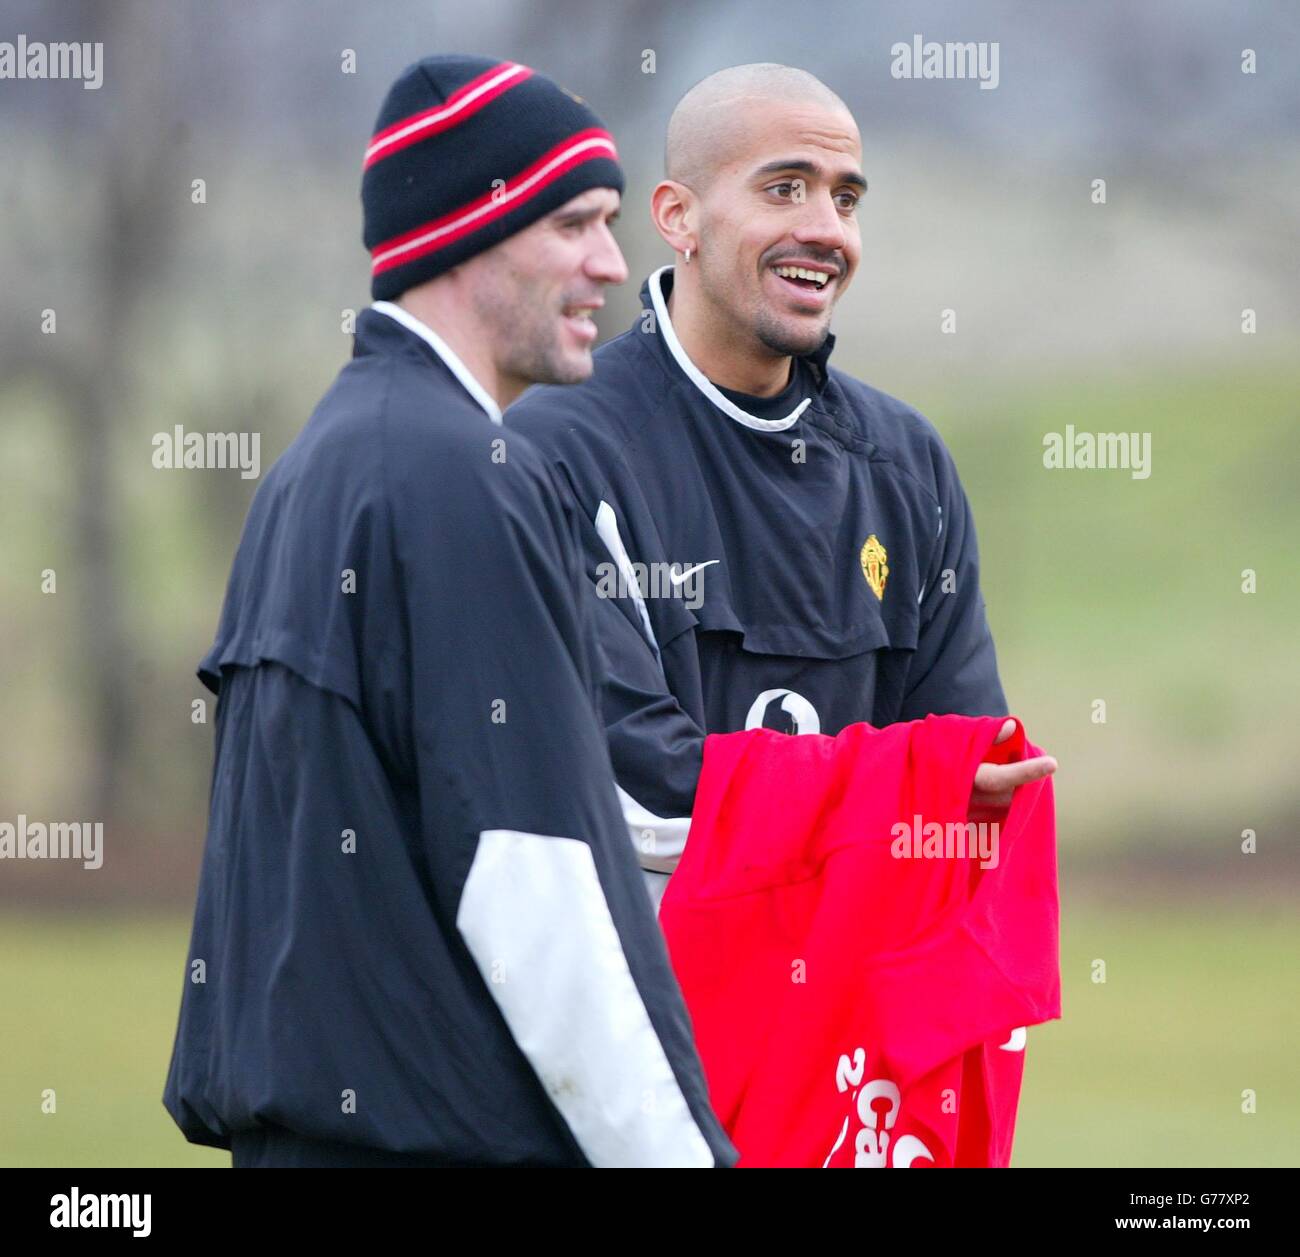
650;64;867;396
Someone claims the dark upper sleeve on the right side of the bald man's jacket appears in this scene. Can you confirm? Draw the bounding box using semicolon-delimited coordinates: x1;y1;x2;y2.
898;438;1006;720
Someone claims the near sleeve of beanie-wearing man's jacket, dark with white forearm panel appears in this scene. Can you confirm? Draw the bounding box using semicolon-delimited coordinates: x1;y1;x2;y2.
390;434;736;1166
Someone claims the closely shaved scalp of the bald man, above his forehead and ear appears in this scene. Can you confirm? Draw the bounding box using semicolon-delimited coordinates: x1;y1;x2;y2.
664;61;849;191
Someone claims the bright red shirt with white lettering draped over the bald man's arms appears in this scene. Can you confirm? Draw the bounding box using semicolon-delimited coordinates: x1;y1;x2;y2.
659;716;1061;1167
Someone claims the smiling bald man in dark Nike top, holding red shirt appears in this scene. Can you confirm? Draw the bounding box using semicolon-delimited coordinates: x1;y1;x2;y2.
507;65;1054;900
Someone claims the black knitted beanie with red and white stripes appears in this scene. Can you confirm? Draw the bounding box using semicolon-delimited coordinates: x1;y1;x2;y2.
361;56;623;300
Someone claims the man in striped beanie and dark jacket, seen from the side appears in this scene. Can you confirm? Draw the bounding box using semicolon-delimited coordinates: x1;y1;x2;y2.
164;56;736;1166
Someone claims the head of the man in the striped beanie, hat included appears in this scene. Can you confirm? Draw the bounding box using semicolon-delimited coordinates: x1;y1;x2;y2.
361;57;628;392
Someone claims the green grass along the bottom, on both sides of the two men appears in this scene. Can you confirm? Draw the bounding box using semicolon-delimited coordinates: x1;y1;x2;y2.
0;900;1300;1166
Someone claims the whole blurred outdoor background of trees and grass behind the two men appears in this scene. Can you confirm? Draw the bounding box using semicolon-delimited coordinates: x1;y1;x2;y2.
0;0;1300;1166
